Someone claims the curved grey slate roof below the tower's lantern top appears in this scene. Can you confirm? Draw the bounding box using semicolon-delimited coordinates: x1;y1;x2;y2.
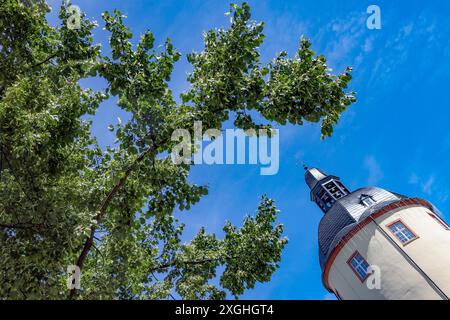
319;187;406;270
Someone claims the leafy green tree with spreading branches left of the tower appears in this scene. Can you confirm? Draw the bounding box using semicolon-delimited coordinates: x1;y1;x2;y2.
0;0;354;299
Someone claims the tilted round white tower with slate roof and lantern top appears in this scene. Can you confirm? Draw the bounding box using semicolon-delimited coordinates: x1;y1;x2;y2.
305;168;450;300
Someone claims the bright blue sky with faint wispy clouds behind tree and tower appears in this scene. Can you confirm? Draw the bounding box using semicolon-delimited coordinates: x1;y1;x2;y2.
49;0;450;299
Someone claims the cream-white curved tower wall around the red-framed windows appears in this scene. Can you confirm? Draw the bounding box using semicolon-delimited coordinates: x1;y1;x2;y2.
323;199;450;300
